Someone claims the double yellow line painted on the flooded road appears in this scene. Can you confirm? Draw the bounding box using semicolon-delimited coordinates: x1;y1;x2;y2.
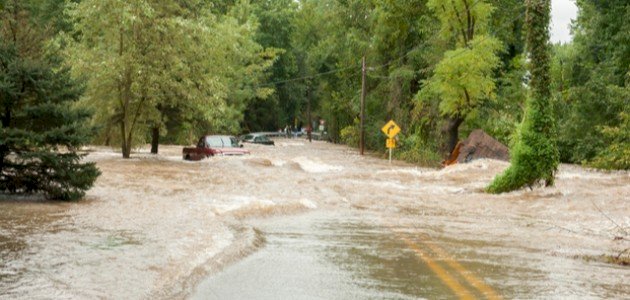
389;218;502;300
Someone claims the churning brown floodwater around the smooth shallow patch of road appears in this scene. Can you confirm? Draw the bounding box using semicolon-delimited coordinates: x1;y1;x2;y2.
0;140;630;299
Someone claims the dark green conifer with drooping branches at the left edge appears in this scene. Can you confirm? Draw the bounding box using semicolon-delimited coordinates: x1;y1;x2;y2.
0;1;100;200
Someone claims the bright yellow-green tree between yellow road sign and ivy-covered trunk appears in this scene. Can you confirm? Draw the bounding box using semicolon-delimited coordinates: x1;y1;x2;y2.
418;0;502;153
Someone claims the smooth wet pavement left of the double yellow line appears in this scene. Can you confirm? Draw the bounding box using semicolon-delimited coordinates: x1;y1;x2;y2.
193;212;472;299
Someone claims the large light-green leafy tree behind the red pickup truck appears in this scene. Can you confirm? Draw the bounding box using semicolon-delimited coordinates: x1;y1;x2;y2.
69;0;275;158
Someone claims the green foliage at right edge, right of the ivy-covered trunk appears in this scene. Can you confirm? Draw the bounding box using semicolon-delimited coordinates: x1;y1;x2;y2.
551;0;630;169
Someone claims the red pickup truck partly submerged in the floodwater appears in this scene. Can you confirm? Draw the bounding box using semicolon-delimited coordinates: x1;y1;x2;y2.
182;135;249;160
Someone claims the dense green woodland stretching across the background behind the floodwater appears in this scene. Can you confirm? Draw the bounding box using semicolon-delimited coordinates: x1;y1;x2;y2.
0;0;630;199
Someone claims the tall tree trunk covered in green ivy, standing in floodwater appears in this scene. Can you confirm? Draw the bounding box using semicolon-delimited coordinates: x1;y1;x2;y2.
488;0;559;193
